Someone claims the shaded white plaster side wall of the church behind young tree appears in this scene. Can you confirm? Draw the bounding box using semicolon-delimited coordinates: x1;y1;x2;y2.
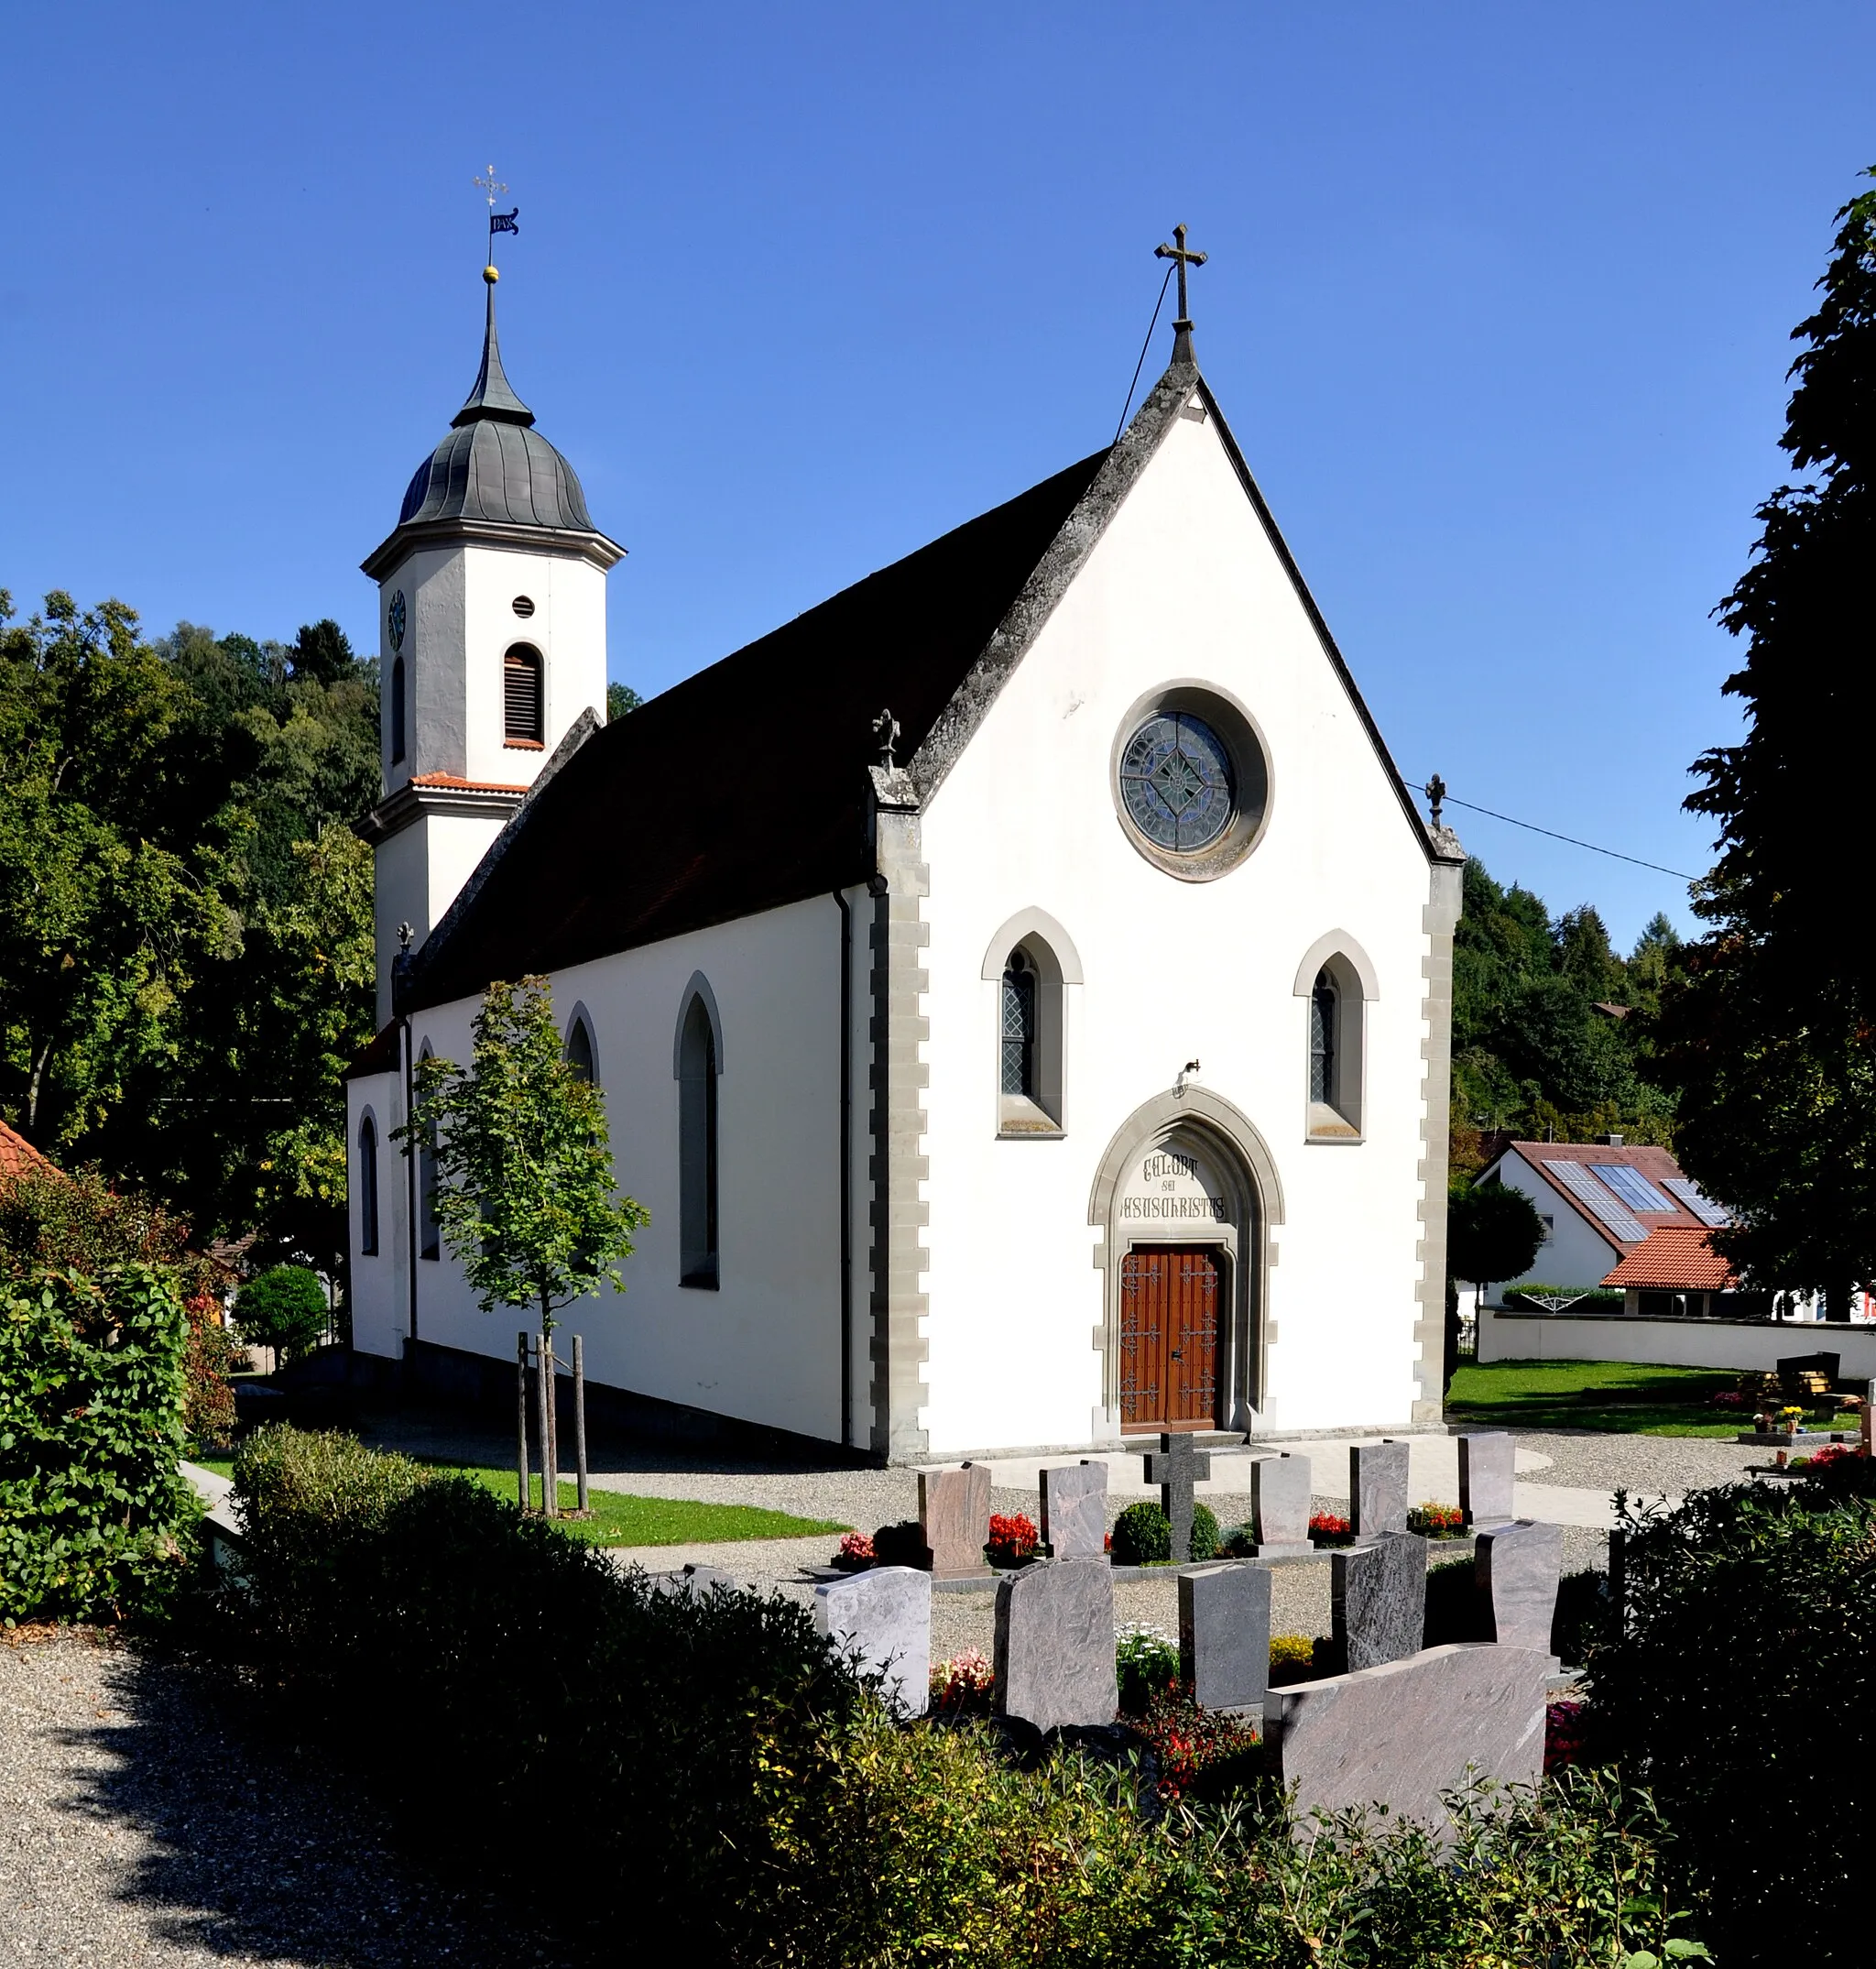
405;898;864;1439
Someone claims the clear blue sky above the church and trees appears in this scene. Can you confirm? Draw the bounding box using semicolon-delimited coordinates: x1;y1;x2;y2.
0;0;1876;946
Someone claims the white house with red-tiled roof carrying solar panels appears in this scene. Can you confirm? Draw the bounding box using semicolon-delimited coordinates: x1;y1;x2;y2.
1478;1134;1740;1311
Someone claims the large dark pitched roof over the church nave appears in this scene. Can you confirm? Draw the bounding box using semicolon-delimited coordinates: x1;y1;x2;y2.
395;451;1107;1006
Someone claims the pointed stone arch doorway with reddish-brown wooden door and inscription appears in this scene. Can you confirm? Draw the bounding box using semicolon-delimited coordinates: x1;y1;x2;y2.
1088;1087;1283;1439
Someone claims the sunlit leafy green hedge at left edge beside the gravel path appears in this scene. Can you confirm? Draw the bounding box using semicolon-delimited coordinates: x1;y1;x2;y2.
0;1264;197;1626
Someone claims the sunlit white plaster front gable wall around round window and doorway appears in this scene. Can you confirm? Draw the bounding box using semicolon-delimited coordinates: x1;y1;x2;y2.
923;395;1443;1455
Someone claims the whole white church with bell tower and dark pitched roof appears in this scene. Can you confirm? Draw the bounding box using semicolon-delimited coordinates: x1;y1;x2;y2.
348;261;1463;1463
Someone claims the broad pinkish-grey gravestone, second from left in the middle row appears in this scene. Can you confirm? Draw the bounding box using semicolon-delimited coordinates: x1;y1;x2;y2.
994;1559;1120;1731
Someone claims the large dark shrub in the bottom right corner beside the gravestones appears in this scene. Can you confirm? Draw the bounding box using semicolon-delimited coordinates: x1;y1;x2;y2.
1587;1459;1876;1964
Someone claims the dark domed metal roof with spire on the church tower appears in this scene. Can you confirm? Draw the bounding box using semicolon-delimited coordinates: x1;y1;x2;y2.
398;286;594;533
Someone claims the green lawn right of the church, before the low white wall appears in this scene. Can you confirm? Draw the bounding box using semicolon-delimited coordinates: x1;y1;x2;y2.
1447;1361;1854;1441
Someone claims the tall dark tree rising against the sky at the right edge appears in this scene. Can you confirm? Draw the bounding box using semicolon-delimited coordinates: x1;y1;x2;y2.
1662;173;1876;1318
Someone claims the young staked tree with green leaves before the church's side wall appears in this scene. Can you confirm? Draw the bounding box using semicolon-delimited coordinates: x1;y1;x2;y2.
394;979;649;1516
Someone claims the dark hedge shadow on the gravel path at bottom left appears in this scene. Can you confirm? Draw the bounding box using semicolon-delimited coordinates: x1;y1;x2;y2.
65;1652;594;1969
